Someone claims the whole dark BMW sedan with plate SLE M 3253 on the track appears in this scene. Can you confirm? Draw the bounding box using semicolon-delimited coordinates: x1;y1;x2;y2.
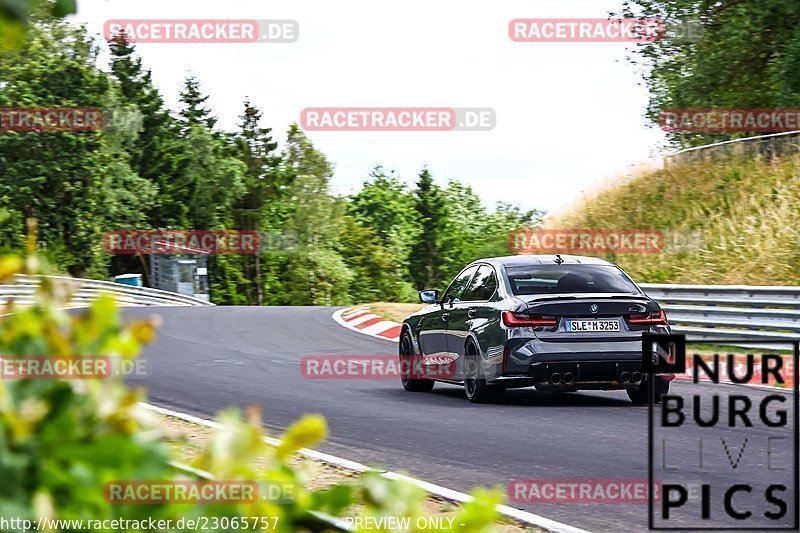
400;255;671;403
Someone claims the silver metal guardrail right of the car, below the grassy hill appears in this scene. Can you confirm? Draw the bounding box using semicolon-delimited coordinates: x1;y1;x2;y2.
641;283;800;341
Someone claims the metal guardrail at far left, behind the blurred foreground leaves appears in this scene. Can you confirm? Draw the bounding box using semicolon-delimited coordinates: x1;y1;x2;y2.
0;276;213;307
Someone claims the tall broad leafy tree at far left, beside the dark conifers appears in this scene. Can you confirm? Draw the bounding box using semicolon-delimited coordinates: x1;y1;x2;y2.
0;23;152;276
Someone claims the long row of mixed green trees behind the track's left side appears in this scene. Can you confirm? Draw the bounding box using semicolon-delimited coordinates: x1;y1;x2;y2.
0;18;538;305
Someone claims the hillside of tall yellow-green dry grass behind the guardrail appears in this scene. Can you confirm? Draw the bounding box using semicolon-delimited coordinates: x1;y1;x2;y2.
546;156;800;285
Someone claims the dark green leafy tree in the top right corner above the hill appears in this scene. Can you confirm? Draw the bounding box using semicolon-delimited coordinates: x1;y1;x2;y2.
621;0;800;146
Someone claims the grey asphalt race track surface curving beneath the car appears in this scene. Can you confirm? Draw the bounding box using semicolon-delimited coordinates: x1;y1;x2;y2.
124;307;797;531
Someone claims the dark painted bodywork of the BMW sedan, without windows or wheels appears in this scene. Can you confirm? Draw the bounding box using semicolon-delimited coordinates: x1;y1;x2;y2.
403;256;670;390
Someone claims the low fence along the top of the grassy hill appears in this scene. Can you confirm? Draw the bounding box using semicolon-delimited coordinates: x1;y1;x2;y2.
664;131;800;167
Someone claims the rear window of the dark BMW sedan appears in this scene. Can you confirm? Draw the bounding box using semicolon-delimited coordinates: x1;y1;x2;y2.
506;265;641;295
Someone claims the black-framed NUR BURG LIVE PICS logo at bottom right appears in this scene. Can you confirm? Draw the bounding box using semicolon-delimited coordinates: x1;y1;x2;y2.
642;334;800;531
